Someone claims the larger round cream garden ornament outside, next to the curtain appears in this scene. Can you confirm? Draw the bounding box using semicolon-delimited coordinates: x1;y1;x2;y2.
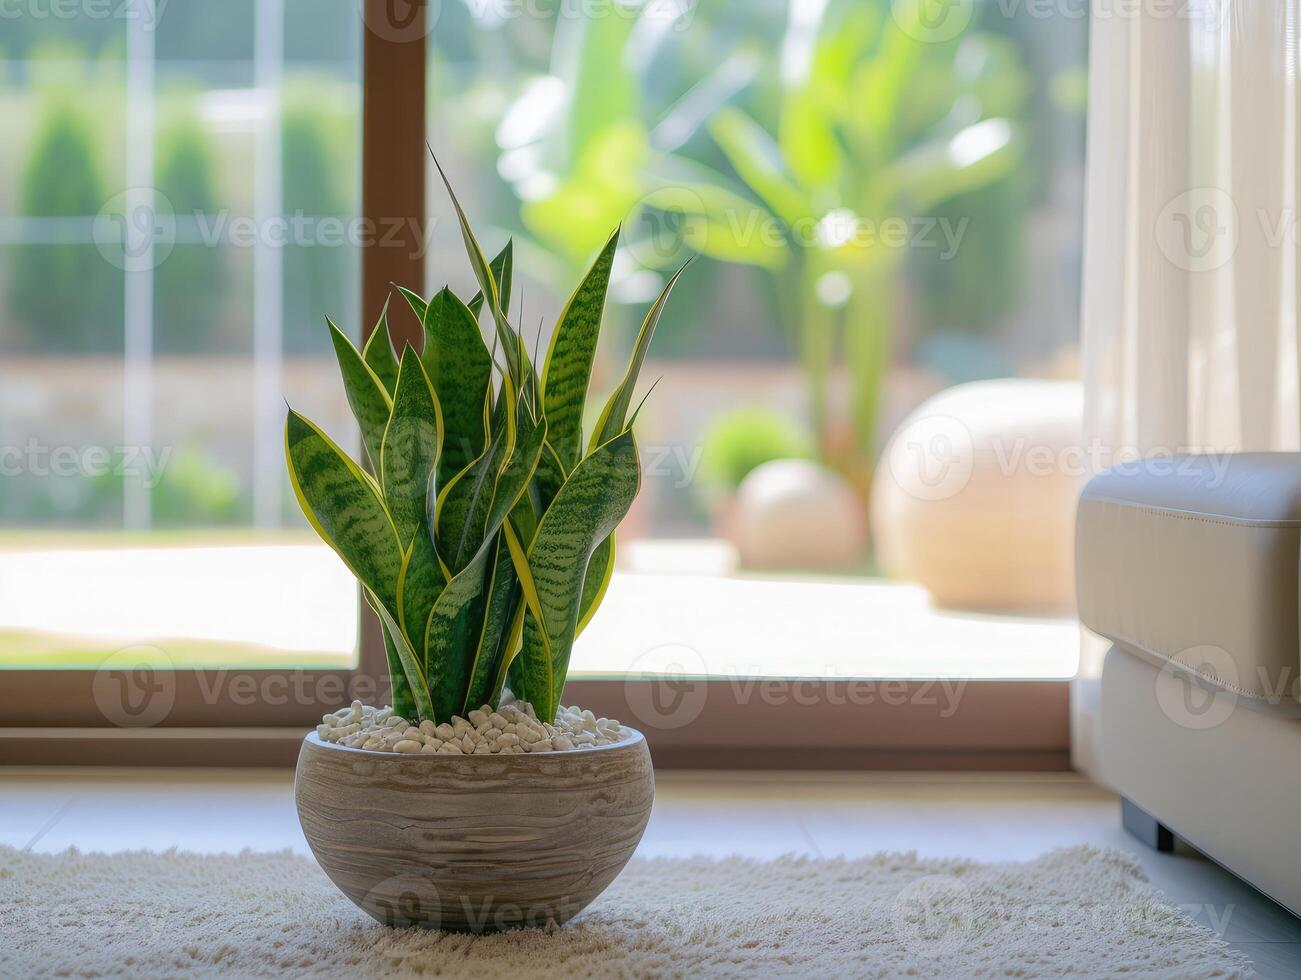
872;379;1089;612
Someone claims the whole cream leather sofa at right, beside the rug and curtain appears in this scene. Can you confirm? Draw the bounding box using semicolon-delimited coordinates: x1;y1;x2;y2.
1076;453;1301;914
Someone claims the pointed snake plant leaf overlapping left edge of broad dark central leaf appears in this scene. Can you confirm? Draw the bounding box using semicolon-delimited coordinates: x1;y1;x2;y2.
380;344;444;546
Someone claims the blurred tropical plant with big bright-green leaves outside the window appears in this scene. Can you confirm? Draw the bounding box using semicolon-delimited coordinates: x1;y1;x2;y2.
498;0;1028;470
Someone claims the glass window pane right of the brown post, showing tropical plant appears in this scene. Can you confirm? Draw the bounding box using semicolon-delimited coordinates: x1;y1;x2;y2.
427;0;1088;678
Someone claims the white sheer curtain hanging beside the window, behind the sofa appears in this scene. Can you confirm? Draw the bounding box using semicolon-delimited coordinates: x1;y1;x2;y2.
1072;0;1301;772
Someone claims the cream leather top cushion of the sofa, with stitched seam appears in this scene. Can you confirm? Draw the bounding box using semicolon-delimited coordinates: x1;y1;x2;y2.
1076;453;1301;715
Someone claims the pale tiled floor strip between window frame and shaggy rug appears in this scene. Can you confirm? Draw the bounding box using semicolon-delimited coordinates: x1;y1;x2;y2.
0;769;1301;977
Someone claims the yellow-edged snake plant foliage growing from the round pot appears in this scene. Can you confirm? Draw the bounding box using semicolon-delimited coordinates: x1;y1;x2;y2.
285;166;677;721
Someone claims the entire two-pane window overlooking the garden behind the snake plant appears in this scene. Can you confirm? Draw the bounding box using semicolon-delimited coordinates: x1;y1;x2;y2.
0;0;1086;754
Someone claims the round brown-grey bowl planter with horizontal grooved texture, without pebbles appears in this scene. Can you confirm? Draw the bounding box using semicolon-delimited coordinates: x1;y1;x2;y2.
294;731;654;932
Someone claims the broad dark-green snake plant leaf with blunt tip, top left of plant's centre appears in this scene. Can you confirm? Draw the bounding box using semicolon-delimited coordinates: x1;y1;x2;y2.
420;288;492;487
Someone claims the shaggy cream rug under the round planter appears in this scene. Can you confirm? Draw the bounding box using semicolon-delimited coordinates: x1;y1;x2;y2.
0;847;1250;980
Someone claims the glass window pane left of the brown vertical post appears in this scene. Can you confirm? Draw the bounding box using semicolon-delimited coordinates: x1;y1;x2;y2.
0;0;362;668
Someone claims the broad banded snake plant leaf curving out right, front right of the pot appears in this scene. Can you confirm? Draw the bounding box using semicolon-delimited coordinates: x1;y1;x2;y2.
507;429;641;721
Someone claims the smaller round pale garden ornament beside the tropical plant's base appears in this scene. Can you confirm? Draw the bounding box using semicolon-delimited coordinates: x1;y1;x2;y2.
729;459;868;569
